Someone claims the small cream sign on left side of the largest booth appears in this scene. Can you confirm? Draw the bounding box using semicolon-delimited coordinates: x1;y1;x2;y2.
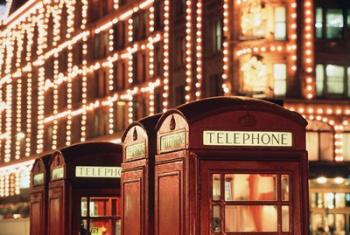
160;131;186;152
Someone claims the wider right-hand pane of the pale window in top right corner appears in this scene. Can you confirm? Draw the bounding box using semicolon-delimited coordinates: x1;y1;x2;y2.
326;9;344;39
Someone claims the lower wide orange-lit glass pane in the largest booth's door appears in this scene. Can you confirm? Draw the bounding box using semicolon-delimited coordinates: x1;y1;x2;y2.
225;206;277;232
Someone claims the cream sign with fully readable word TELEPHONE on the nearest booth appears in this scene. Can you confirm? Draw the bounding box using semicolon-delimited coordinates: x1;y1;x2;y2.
203;130;293;147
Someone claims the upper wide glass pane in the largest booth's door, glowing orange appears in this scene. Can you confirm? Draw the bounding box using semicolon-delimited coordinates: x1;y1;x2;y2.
225;174;277;201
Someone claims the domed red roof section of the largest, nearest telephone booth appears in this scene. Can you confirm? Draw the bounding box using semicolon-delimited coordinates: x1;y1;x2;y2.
156;97;307;153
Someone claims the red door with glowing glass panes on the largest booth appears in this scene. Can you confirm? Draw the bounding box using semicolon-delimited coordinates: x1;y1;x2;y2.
200;161;303;235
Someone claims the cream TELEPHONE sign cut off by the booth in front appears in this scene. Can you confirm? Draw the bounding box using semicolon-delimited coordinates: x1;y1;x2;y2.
75;166;122;178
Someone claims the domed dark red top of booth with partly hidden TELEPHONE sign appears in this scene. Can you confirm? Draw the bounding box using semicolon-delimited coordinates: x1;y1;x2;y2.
50;142;122;180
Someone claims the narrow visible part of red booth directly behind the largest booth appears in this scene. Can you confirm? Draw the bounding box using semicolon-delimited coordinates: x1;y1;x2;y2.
121;114;160;235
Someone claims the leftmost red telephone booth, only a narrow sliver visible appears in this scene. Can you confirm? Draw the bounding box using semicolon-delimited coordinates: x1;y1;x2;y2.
29;154;51;235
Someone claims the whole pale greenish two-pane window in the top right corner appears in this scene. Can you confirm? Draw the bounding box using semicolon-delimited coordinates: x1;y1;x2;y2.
315;7;350;39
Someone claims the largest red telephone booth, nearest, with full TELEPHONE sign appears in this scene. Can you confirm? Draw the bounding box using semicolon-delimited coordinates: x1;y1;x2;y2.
155;97;308;235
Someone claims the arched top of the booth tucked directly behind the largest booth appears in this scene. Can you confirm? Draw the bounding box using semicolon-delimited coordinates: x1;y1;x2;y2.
122;113;161;161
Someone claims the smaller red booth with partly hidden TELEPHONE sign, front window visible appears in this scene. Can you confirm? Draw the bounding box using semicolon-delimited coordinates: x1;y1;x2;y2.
47;143;122;235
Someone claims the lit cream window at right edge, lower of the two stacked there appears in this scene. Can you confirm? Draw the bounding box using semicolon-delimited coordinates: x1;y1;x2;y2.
316;64;350;98
